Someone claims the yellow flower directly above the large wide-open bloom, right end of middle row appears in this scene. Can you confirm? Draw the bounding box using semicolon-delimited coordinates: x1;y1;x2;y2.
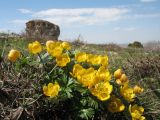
96;66;111;81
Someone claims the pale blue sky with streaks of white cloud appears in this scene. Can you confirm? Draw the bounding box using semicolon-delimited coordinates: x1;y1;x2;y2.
0;0;160;44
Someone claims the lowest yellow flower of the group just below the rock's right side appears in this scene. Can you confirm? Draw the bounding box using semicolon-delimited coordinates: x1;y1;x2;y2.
56;54;70;67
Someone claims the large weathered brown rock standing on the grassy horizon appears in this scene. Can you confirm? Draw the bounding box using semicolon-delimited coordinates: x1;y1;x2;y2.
26;20;60;40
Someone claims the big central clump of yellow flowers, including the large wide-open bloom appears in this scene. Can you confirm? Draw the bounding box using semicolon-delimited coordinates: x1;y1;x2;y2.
71;52;113;101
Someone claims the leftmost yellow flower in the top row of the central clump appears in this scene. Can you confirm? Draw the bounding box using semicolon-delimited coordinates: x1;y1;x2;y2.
75;52;87;62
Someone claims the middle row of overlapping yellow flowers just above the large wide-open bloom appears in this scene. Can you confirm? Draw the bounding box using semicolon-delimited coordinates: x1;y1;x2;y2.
71;64;111;88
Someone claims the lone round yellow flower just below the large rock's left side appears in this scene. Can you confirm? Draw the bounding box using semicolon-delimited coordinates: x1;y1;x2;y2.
28;41;42;54
